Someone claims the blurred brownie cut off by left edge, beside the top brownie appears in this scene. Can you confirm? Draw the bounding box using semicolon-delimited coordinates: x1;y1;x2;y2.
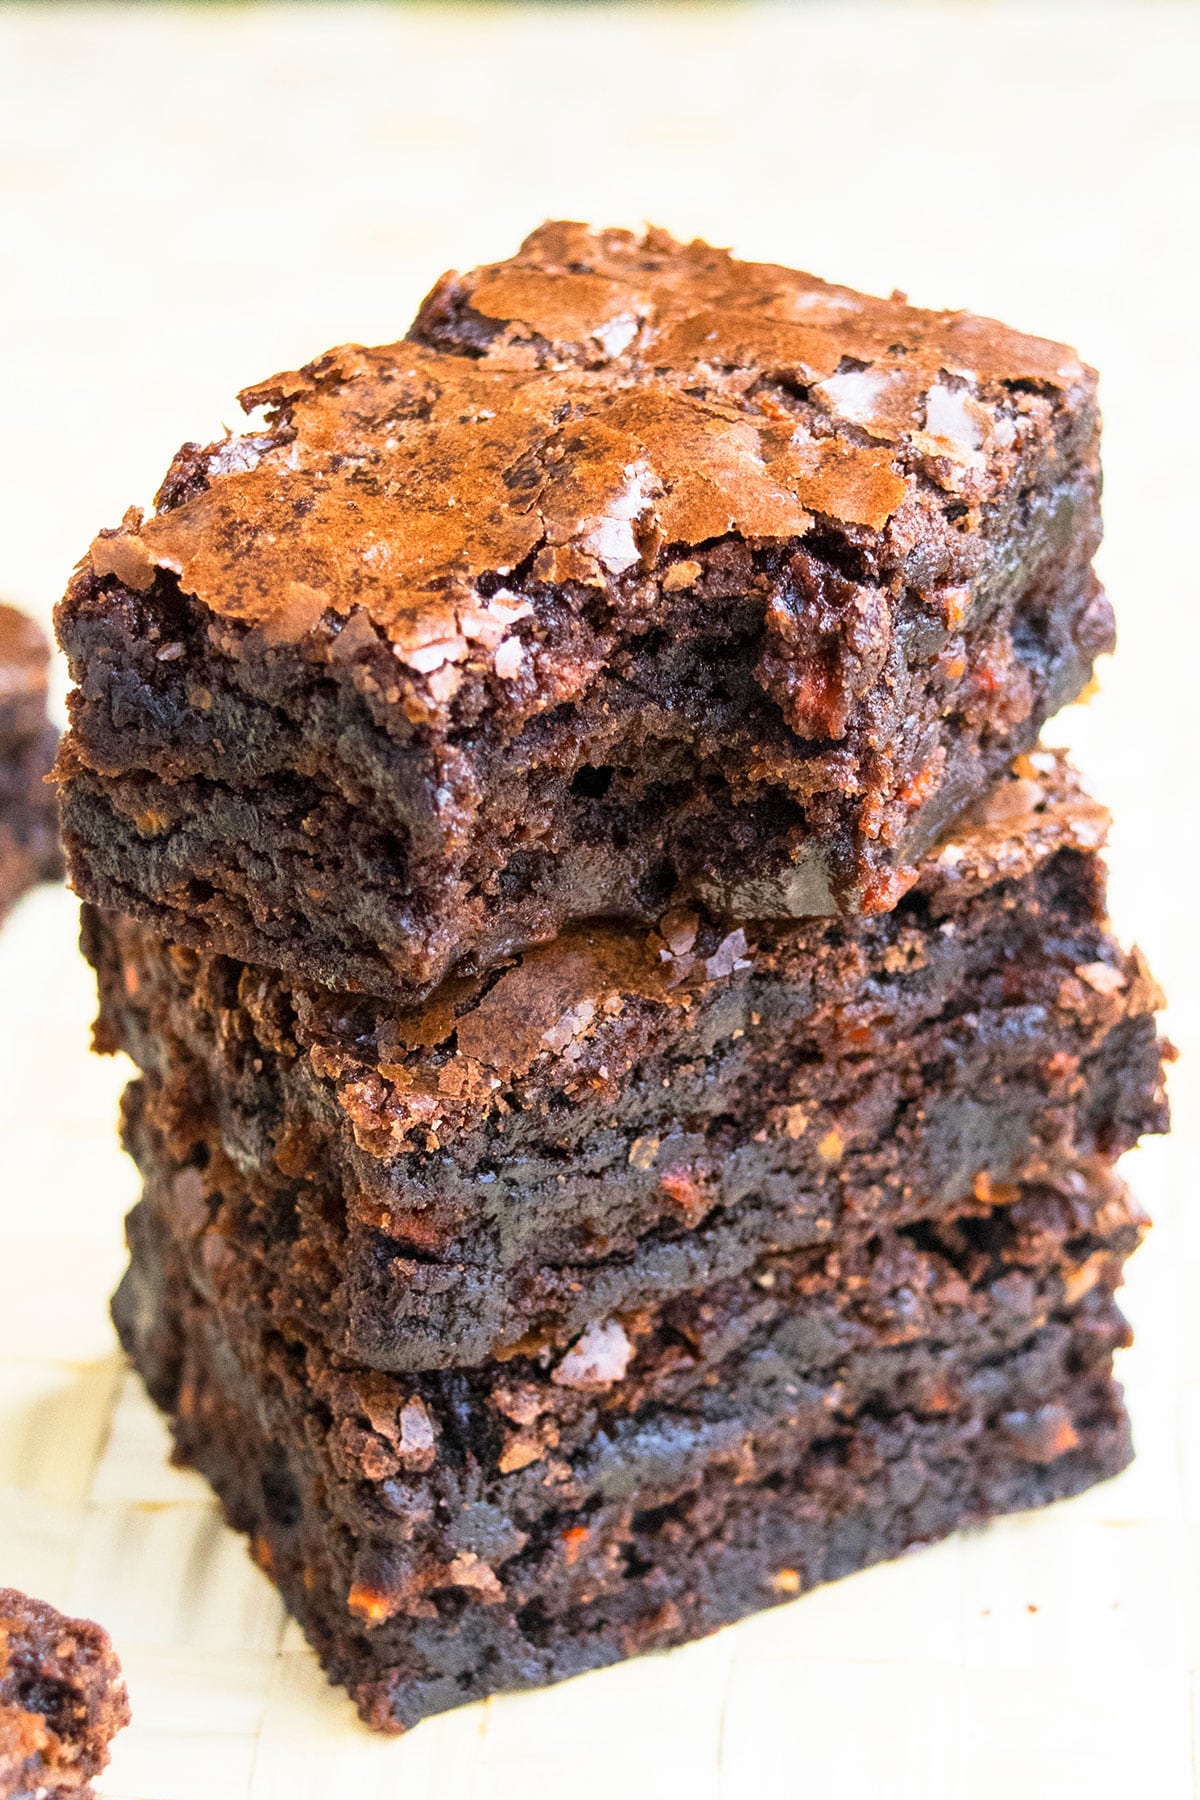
0;605;63;918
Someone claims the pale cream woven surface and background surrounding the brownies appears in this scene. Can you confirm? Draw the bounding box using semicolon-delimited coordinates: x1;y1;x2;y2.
0;0;1200;1800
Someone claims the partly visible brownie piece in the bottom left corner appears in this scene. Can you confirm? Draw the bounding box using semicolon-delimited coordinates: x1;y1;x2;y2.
0;1588;130;1800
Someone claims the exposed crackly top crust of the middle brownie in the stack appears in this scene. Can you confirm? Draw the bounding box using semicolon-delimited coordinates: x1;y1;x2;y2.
107;751;1160;1159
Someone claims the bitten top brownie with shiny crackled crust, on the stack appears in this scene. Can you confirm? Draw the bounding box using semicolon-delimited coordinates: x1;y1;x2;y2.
59;223;1112;1001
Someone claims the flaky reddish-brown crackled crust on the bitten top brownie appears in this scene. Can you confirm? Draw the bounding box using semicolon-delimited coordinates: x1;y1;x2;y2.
82;223;1094;704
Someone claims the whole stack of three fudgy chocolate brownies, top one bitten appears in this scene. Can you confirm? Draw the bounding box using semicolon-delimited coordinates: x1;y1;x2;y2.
51;225;1166;1730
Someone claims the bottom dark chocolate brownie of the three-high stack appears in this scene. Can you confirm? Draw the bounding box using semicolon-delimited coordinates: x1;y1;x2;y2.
115;1170;1141;1730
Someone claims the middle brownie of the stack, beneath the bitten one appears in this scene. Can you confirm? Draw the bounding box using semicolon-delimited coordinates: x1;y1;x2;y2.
85;752;1166;1368
